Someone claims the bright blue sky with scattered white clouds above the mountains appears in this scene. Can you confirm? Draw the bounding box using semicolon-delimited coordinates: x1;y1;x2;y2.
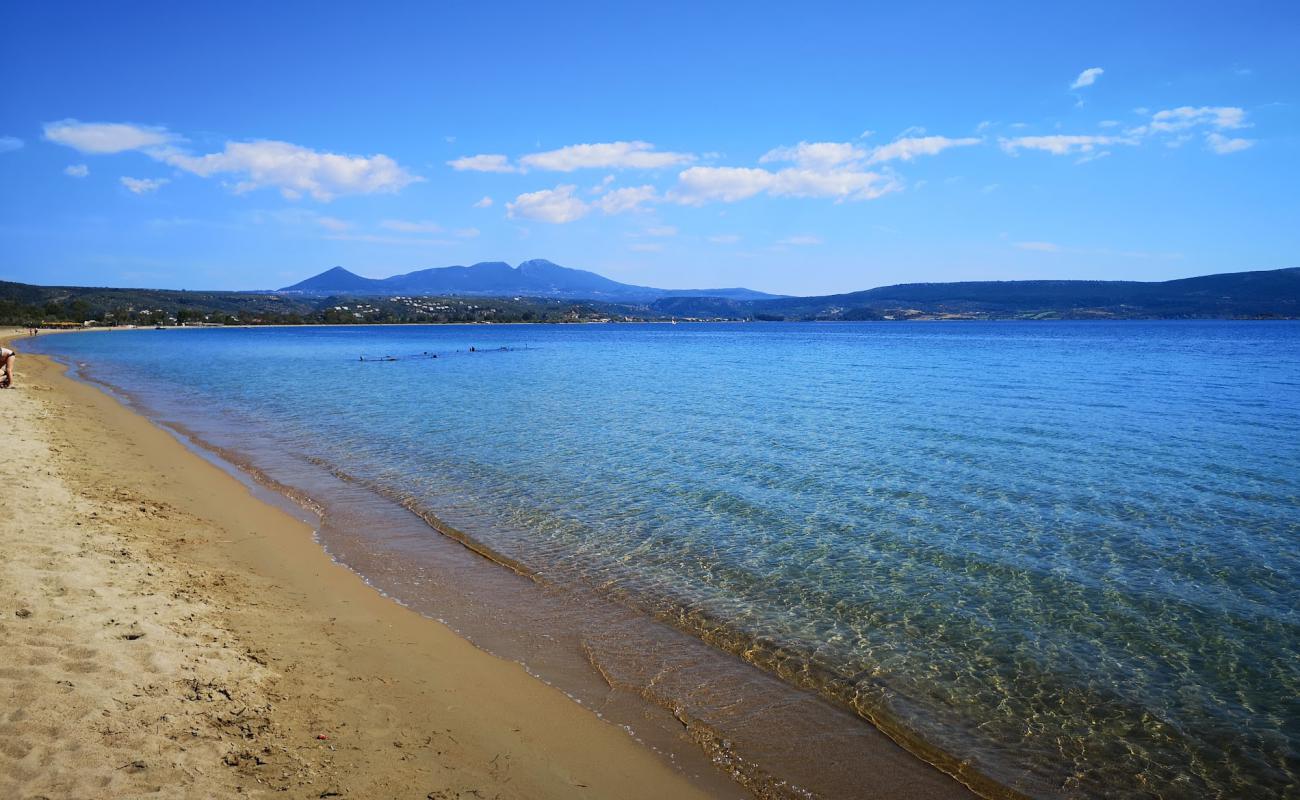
0;1;1300;294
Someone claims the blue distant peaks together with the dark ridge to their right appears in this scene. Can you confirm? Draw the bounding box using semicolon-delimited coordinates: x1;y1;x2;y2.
280;259;1300;320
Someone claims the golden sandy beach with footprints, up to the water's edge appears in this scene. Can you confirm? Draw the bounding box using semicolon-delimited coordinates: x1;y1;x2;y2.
0;340;722;799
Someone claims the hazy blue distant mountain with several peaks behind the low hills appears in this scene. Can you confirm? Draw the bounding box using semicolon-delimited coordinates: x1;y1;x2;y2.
280;259;783;303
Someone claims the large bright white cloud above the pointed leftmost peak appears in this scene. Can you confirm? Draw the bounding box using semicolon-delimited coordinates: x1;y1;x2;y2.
150;139;424;200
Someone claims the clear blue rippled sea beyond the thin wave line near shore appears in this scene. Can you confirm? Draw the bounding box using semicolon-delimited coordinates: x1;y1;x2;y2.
27;323;1300;797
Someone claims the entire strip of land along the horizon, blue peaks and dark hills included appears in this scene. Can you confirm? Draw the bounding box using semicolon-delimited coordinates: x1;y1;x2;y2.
0;261;1300;325
